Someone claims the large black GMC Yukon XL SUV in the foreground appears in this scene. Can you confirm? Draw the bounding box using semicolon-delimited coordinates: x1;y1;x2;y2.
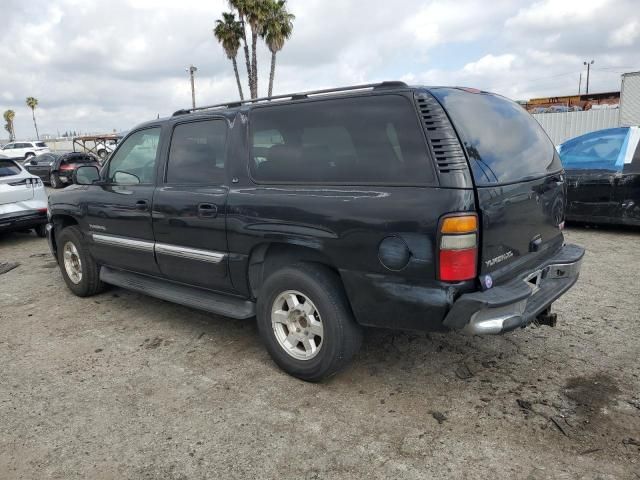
48;82;584;381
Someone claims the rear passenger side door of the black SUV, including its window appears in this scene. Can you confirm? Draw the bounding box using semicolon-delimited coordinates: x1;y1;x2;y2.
153;118;233;291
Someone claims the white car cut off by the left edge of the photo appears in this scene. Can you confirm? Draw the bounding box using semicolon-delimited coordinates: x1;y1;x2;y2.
0;159;47;237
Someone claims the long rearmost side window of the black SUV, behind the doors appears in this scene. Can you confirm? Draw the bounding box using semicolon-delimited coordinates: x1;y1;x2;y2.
250;95;433;185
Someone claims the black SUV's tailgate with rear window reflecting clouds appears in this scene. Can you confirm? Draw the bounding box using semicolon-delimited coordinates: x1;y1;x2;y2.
431;88;566;281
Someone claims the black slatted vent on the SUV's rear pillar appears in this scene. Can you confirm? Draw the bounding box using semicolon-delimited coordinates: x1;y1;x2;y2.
416;94;467;173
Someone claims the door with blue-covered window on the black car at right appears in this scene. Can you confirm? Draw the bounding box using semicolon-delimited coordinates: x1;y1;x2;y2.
559;128;629;222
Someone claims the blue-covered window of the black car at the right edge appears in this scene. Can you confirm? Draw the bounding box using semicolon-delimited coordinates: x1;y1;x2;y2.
560;128;628;170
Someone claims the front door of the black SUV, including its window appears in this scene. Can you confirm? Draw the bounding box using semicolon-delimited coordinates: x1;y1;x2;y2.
81;127;161;274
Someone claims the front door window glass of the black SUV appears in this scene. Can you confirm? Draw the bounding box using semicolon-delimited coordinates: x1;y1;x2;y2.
107;127;160;185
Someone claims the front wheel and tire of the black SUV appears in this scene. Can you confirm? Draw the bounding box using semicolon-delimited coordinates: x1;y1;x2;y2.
56;226;104;297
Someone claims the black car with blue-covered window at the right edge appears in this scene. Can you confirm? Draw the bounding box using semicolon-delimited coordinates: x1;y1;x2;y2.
558;127;640;225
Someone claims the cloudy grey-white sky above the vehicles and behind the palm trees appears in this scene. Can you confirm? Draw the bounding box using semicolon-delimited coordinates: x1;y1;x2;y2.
0;0;640;139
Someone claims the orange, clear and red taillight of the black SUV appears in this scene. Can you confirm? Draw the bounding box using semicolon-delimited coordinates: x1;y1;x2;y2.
438;214;478;282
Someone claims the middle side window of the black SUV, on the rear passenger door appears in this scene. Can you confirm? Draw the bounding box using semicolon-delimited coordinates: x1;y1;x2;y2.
167;120;227;184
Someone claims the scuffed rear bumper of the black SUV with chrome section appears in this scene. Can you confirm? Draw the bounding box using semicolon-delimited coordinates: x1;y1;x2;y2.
443;245;584;335
